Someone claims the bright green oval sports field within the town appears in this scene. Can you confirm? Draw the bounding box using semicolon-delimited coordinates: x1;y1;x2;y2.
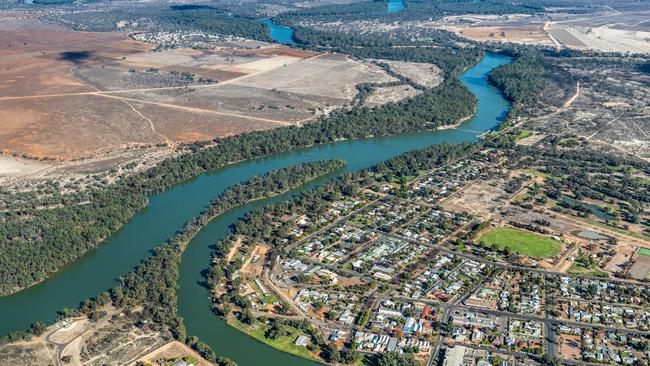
479;227;560;258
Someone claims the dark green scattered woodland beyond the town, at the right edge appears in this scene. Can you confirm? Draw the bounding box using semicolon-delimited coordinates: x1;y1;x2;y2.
486;137;650;233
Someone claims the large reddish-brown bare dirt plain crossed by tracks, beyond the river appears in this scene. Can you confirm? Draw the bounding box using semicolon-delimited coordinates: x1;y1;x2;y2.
0;13;394;166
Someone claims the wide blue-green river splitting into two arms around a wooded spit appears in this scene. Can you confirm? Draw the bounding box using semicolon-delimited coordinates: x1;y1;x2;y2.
0;50;510;366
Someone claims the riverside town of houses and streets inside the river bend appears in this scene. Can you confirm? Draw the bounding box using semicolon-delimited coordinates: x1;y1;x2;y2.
214;144;650;365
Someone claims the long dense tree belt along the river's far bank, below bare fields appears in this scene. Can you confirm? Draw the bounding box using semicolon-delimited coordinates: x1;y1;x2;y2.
0;67;476;294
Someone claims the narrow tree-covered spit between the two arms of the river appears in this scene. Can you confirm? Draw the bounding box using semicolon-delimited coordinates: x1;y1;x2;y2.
0;160;345;354
